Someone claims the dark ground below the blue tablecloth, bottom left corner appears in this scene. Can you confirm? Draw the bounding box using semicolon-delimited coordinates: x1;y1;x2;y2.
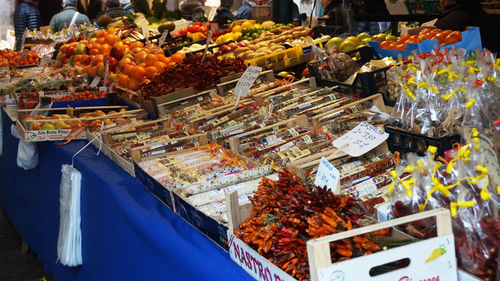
0;203;52;281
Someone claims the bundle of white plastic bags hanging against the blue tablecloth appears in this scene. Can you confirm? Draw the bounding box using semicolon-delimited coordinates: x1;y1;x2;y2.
57;165;82;266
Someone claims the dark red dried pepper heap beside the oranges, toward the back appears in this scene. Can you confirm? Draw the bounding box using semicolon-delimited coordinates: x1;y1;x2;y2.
139;54;246;99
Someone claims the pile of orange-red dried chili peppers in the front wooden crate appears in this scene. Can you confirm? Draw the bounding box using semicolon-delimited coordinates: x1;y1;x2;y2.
235;170;387;280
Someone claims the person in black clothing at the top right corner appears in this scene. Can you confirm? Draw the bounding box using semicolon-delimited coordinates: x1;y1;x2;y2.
434;0;500;54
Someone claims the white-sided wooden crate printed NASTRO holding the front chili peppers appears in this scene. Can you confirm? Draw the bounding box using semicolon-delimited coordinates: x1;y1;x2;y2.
226;192;457;281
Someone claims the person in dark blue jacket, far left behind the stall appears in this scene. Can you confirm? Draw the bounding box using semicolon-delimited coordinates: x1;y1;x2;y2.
14;0;41;51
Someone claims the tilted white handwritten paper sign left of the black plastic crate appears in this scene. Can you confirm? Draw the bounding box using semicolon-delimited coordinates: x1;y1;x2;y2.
333;122;389;157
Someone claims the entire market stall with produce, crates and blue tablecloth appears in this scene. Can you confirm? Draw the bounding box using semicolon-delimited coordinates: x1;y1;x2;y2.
0;1;500;281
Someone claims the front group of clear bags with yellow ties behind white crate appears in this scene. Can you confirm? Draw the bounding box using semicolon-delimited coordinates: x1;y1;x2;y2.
386;129;500;280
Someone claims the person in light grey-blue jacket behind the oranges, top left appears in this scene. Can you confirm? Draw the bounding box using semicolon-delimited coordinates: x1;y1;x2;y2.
50;0;92;32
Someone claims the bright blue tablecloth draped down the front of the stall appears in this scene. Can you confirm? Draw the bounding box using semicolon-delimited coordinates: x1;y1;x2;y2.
0;110;253;281
